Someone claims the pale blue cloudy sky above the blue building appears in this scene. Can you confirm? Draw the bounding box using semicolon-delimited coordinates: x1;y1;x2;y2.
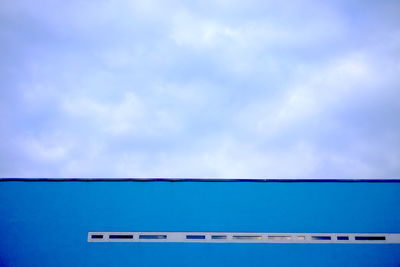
0;0;400;179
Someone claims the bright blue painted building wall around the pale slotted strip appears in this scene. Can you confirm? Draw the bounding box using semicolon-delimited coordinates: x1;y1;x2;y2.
0;182;400;266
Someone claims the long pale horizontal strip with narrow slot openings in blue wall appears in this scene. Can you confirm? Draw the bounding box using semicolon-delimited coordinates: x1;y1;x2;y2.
87;232;400;244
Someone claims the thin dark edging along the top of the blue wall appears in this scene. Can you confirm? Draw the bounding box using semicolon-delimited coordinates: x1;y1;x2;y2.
0;178;400;183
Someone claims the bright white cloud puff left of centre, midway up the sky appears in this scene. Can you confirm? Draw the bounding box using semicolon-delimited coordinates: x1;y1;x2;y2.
63;92;180;136
